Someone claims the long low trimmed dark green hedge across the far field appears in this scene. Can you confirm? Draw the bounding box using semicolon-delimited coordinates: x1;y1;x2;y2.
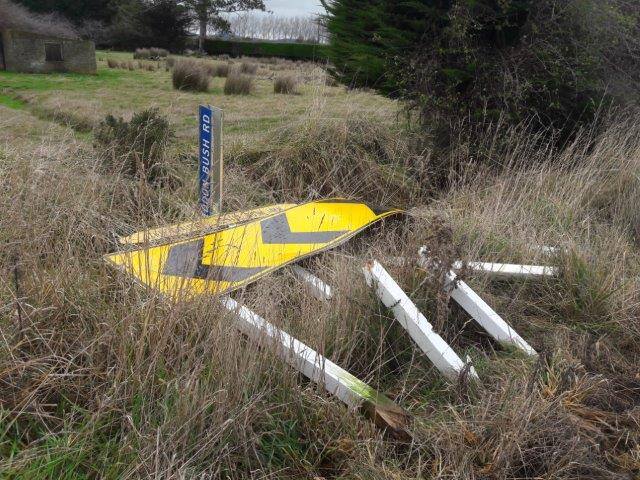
204;39;328;61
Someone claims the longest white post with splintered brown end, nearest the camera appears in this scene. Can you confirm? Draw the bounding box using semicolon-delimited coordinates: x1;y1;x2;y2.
221;297;409;438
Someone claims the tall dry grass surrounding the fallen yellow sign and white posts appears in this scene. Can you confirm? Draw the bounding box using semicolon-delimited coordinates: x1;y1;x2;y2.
0;57;640;479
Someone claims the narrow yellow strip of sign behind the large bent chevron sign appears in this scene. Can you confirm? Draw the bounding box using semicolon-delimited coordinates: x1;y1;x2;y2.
118;203;296;245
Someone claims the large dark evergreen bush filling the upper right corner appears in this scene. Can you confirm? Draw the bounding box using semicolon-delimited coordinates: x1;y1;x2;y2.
328;0;640;139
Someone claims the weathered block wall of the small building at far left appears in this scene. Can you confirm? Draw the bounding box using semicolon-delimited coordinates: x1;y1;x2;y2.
0;30;97;73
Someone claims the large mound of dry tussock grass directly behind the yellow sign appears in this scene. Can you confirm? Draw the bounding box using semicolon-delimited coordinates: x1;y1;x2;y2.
238;117;422;205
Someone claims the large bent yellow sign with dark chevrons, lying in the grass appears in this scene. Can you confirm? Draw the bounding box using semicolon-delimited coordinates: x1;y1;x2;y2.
106;199;400;299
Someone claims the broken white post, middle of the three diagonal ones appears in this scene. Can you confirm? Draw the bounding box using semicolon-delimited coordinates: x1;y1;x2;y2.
363;261;477;381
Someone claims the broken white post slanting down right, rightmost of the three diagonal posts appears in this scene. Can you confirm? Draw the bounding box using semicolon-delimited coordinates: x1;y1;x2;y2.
420;249;537;356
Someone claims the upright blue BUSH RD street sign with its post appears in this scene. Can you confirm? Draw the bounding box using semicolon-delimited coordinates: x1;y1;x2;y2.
198;105;223;216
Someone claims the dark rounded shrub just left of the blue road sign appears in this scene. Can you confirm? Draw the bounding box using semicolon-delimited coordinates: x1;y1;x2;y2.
95;108;173;183
